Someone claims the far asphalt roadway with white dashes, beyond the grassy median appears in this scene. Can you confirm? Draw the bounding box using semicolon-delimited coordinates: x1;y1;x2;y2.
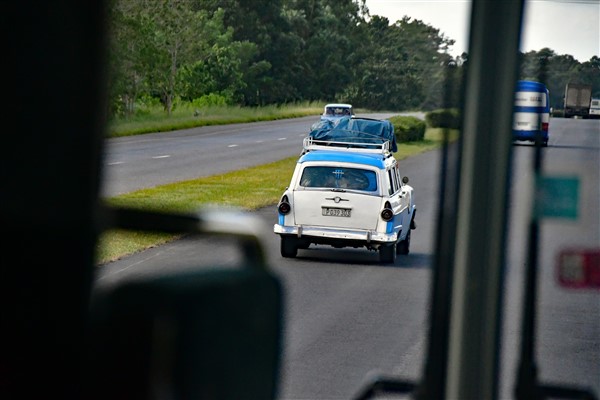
101;112;412;197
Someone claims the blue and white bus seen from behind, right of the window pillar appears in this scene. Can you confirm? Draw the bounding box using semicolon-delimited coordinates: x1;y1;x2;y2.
512;80;550;146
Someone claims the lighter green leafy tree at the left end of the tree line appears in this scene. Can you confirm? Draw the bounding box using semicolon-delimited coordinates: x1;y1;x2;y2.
111;0;248;115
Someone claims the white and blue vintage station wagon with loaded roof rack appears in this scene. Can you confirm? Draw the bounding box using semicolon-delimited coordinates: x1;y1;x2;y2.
274;118;416;263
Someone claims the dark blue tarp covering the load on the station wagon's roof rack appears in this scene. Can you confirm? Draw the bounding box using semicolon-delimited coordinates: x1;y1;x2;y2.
309;117;398;152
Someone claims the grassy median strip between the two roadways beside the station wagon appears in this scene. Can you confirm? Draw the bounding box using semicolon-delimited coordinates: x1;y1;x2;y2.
96;129;454;265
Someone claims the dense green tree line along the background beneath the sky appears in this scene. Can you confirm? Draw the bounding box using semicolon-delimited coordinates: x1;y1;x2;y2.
109;0;600;115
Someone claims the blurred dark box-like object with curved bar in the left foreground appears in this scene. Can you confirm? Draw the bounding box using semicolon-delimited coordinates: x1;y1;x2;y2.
85;208;283;400
